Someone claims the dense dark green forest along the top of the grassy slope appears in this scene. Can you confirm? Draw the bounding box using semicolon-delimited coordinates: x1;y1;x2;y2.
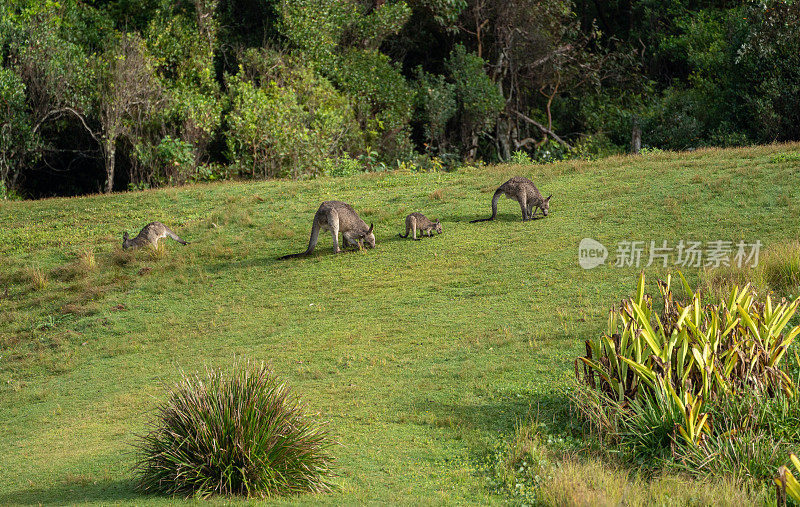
0;0;800;198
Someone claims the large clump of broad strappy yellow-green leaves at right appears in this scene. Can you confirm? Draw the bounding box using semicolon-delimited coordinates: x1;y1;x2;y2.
573;275;800;484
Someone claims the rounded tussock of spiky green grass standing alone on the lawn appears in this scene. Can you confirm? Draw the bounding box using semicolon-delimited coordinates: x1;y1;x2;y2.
136;363;333;497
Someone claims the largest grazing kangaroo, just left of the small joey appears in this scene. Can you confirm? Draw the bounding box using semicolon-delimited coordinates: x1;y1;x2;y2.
279;201;375;259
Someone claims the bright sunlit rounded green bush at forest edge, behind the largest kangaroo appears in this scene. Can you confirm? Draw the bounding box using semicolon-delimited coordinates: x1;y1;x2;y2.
227;51;362;177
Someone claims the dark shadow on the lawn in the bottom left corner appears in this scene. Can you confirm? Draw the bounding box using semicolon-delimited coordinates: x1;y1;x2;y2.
0;479;145;505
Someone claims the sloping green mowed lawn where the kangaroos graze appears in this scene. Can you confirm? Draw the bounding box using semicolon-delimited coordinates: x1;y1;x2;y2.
0;144;800;505
